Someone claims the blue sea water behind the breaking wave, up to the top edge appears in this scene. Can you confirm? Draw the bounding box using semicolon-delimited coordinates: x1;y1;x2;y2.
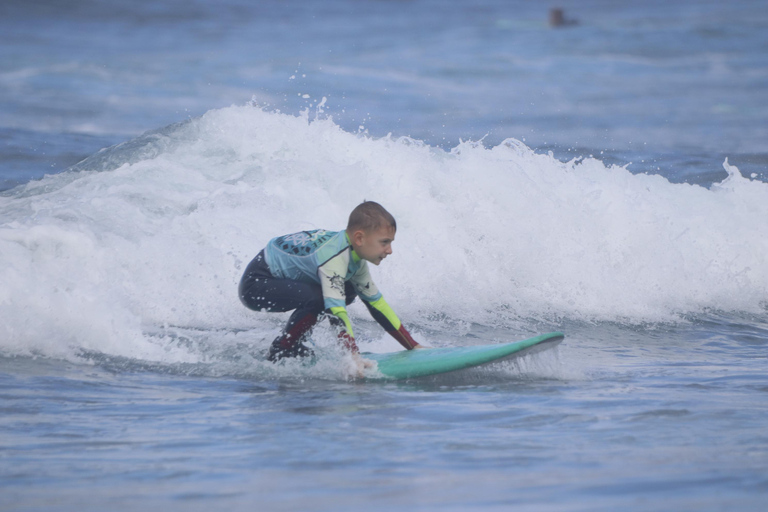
0;0;768;186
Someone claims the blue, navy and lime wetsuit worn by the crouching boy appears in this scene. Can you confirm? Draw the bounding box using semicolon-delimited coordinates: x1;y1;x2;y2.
239;230;417;358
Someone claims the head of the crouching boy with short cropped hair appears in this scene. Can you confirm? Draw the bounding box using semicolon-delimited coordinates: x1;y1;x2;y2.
347;201;397;265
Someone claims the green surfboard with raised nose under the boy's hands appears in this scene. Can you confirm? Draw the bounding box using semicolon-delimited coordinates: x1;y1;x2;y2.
362;332;565;379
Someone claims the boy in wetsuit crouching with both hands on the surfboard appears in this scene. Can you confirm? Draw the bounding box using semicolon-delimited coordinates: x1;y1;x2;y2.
239;201;422;374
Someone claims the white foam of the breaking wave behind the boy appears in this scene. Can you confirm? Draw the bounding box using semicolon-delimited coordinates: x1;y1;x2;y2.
0;106;768;361
